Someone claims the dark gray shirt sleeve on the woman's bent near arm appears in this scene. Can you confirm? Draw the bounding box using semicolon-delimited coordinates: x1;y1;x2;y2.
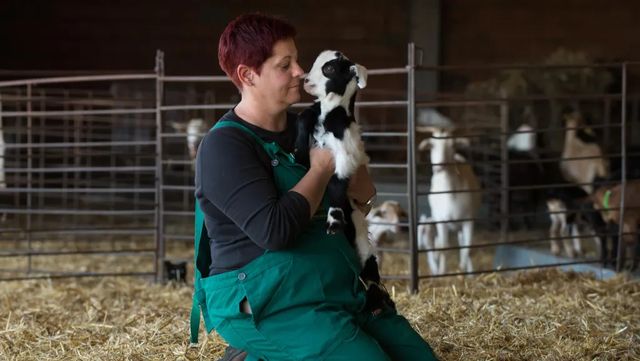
198;128;310;250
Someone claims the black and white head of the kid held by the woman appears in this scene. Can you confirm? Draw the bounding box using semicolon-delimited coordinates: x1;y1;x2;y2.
304;50;367;100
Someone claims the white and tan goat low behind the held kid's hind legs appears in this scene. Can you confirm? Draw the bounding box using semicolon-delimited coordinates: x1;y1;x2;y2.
367;201;407;268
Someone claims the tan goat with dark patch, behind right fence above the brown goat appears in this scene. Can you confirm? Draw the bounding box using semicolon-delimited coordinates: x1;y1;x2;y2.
560;112;608;194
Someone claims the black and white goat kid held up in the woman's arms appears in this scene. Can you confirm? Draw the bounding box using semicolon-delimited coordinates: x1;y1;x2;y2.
295;50;395;312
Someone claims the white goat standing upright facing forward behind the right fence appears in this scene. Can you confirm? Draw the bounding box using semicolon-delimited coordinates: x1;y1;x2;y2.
418;128;481;275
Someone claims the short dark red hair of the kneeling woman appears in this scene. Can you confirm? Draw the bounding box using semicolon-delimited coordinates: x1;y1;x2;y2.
218;13;296;89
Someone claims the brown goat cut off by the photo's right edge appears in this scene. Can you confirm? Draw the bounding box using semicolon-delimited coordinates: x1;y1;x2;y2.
591;180;640;270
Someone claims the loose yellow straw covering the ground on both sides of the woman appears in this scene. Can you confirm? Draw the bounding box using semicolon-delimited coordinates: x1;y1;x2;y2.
0;270;640;360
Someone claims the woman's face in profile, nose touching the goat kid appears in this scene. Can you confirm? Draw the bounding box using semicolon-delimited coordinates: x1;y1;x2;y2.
254;39;304;111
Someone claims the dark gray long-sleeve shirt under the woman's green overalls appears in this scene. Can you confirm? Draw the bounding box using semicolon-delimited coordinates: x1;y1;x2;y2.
195;110;310;275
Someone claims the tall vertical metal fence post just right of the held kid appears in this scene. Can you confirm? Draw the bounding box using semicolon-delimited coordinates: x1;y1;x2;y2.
405;43;418;293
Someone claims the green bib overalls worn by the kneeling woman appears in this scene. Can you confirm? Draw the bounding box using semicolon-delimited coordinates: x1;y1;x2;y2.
191;120;436;361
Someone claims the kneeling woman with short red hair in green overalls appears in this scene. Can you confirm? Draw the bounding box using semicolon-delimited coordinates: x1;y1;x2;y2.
192;14;435;361
